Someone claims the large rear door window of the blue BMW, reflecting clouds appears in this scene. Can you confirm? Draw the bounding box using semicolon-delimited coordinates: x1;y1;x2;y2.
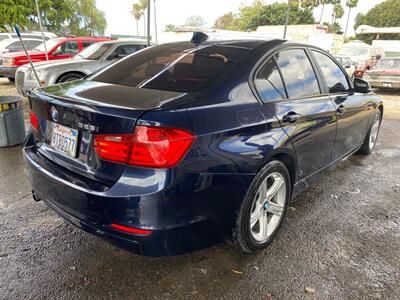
275;49;321;98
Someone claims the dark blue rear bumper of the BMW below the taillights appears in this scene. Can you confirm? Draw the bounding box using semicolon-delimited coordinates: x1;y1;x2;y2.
24;133;253;256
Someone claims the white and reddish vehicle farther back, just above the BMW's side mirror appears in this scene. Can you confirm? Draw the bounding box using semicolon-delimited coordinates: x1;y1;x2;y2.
339;41;385;78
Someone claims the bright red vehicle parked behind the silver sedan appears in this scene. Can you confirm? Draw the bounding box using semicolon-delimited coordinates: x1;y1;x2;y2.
0;37;110;81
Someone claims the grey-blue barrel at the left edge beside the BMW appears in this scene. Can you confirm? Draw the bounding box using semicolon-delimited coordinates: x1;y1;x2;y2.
0;96;25;147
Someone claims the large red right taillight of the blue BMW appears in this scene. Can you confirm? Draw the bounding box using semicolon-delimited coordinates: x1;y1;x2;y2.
94;126;196;168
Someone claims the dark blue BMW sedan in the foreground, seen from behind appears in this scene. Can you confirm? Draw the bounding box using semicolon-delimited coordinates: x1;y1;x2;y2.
23;34;383;256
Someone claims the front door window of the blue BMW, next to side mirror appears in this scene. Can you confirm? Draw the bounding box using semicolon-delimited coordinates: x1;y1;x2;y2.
312;50;350;94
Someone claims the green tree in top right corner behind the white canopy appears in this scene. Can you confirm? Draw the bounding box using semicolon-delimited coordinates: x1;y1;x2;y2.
354;0;400;43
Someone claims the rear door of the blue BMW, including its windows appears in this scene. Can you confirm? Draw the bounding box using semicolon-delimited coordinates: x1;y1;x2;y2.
254;48;336;179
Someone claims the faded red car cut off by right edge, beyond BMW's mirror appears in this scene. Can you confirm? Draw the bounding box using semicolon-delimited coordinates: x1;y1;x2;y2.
363;57;400;89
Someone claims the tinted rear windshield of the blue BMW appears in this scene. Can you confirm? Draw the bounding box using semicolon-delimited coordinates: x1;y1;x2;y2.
91;43;248;92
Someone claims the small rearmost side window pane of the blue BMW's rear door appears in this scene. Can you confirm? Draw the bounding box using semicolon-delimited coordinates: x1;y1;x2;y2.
254;58;286;102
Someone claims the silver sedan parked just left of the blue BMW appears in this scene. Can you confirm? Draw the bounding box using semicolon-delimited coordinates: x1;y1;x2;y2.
15;40;146;95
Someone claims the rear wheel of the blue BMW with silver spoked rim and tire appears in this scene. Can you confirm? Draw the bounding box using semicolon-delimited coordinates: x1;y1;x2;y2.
232;160;291;253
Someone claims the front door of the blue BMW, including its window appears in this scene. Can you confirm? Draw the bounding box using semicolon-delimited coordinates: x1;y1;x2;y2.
311;49;373;160
